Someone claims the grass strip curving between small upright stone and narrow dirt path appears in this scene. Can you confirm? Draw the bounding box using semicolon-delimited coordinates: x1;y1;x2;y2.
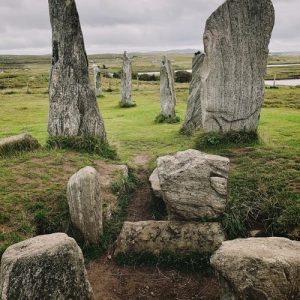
83;170;139;260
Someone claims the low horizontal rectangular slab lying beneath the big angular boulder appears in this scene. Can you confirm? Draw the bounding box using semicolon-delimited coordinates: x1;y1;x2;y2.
115;221;225;255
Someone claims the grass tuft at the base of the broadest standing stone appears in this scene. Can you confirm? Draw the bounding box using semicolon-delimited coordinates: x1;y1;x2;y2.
195;131;259;150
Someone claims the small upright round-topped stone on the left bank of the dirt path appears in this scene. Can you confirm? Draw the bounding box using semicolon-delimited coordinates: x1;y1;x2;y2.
67;167;102;245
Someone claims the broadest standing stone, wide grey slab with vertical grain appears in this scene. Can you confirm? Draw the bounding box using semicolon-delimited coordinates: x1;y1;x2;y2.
188;0;274;132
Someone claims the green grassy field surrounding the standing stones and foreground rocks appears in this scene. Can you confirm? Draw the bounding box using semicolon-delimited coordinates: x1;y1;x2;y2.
0;53;300;253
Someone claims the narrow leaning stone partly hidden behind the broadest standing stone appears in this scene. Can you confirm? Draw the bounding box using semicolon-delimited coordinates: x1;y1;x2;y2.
182;51;204;134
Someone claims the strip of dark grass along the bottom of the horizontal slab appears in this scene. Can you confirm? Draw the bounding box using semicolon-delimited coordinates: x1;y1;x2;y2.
115;252;212;275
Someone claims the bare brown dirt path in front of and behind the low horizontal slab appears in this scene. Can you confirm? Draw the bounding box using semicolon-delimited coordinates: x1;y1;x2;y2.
87;160;219;300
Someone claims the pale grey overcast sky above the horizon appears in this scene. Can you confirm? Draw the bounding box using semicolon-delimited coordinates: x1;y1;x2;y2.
0;0;300;54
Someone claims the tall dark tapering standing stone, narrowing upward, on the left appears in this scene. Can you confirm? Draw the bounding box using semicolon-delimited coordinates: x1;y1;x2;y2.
48;0;106;142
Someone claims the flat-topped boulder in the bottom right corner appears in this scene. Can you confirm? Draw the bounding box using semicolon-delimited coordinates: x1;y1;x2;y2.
211;238;300;300
